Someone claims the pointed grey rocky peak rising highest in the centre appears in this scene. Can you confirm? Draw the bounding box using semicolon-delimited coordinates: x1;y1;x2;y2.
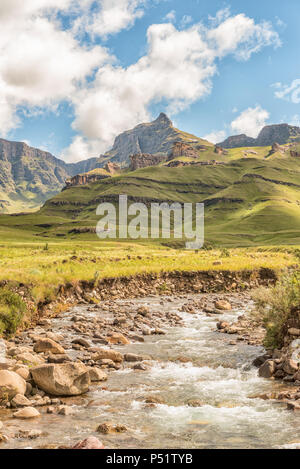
100;113;212;167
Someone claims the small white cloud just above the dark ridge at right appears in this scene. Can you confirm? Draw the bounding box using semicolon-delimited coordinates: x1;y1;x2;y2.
231;106;270;138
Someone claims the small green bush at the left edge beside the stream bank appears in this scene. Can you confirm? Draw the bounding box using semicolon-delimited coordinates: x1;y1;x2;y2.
0;288;26;335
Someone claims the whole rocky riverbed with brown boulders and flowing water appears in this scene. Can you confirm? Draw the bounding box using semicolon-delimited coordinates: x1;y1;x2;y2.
0;293;300;448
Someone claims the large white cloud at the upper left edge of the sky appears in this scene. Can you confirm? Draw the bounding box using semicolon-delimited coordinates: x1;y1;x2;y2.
0;0;112;135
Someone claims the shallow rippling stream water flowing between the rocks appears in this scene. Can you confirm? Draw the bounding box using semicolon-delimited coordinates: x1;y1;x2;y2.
0;295;300;449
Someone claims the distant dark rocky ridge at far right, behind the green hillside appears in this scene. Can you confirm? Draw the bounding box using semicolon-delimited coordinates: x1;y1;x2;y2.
218;124;300;148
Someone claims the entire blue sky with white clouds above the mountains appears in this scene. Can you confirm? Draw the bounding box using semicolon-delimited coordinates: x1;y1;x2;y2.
0;0;300;161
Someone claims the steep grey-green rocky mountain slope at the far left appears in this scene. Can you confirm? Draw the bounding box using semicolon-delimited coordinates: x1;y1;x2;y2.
0;139;100;213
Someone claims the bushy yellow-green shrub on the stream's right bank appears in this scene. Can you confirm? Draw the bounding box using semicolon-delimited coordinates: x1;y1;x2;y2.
253;272;300;349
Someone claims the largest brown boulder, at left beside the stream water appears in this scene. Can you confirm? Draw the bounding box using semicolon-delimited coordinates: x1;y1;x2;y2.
31;363;91;396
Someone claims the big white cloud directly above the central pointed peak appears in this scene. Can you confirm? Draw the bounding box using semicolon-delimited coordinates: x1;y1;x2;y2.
65;13;277;159
